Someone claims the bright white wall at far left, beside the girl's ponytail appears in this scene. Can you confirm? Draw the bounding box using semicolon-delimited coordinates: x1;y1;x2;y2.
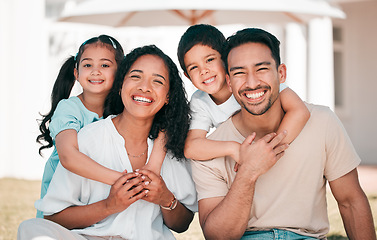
0;0;48;178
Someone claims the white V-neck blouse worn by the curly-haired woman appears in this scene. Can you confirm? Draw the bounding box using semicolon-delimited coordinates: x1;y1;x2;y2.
35;116;197;239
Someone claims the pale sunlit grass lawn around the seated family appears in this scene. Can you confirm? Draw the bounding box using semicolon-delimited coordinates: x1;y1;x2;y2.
0;178;377;240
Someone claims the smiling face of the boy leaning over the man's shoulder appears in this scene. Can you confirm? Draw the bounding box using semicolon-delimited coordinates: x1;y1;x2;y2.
184;44;226;94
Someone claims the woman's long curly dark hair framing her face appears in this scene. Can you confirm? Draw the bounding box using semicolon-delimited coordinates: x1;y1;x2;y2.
104;45;190;159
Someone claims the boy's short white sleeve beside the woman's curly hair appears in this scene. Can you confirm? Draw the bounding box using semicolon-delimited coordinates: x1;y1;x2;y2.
190;94;213;132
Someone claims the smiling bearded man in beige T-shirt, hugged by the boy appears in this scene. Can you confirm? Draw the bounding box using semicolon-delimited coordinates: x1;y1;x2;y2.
192;28;376;239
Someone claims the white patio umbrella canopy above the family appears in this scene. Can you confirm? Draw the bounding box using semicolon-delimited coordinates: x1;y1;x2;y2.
58;0;345;27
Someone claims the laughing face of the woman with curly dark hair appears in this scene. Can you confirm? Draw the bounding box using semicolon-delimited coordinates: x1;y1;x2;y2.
121;55;169;119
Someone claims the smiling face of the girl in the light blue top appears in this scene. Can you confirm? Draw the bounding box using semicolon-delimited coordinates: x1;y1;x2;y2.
74;44;117;95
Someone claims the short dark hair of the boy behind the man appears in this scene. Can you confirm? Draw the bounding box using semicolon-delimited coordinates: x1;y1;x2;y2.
177;24;225;74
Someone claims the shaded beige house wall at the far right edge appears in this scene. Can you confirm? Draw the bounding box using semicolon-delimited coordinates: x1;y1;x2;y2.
334;1;377;164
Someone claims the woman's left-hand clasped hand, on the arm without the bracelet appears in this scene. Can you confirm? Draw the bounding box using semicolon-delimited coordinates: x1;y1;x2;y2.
105;172;145;214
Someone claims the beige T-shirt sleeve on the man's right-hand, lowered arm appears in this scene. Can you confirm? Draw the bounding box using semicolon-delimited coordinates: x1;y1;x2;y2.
325;109;361;182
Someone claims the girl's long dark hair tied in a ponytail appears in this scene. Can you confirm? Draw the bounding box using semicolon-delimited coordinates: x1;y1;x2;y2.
37;35;124;155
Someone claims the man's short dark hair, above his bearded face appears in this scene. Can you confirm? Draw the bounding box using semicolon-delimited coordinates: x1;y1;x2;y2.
221;28;280;73
